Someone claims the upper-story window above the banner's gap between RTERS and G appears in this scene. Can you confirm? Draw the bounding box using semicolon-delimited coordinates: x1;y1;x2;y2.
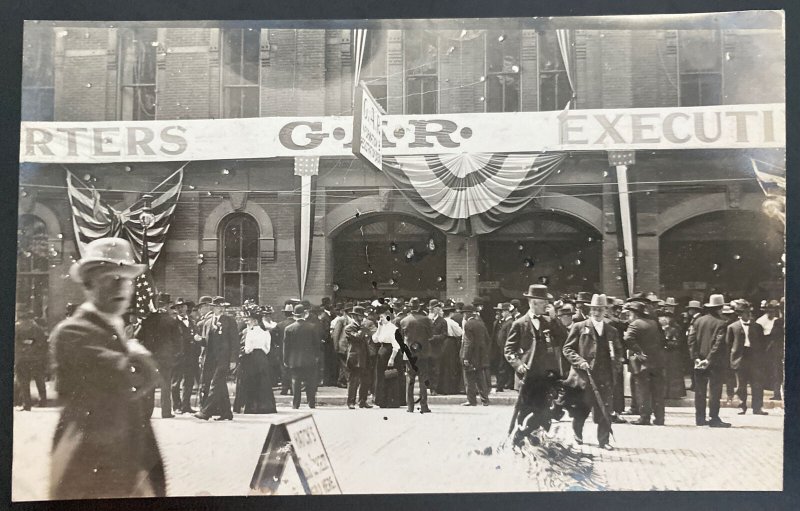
222;28;261;118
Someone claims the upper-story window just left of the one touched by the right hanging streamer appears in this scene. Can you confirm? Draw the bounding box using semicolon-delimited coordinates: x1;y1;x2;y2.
486;30;521;112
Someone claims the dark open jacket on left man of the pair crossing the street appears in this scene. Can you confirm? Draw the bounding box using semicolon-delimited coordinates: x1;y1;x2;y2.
503;314;567;375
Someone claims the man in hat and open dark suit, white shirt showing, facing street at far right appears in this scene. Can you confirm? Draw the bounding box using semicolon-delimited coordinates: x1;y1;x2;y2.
726;300;767;415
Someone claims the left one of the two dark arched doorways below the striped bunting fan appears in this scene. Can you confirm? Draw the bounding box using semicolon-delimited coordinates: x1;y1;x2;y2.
333;213;446;301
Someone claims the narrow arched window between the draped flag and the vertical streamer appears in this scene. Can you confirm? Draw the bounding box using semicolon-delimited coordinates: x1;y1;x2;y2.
220;214;260;305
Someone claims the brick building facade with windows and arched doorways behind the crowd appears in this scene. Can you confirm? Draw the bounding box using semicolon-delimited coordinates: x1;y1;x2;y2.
18;22;785;323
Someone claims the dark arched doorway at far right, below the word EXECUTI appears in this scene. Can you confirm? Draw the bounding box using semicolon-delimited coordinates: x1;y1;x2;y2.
659;210;784;301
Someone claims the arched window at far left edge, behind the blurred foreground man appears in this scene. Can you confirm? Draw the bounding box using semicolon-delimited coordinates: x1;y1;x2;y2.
17;215;50;318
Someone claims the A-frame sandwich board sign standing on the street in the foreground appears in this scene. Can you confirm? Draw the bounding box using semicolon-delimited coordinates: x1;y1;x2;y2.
249;414;342;495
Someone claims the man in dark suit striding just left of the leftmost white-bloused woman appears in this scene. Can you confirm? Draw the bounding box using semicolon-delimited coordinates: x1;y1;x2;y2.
194;296;239;420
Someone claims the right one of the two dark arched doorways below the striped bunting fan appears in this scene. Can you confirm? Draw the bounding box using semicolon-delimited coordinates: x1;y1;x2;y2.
479;212;603;303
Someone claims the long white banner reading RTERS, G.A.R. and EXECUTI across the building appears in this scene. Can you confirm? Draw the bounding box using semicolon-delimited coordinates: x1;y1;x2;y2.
20;103;786;163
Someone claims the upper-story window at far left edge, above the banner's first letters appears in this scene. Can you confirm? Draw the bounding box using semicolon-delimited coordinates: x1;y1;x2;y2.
22;24;55;121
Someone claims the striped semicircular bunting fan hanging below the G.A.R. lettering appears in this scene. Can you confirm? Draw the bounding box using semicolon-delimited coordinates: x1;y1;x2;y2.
383;153;566;235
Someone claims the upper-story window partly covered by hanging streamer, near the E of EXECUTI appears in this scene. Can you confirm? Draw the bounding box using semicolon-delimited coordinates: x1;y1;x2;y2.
536;30;572;111
